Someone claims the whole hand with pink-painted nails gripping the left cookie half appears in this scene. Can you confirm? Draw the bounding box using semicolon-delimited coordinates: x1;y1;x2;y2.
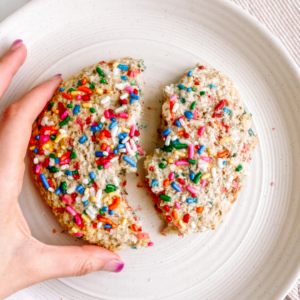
0;40;124;299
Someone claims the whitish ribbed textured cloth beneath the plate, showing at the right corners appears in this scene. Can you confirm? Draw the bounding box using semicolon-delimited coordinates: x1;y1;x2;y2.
231;0;300;300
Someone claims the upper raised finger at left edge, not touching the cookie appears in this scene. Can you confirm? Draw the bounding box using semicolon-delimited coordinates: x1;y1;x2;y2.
0;40;27;98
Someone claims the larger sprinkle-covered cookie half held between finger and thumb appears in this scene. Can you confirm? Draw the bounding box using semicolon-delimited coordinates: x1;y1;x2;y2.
29;58;153;251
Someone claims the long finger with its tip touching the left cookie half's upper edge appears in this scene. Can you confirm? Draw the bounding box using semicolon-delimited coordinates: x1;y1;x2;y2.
0;74;62;167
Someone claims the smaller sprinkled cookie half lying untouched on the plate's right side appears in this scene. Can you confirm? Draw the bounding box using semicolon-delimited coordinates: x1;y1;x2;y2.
144;65;258;235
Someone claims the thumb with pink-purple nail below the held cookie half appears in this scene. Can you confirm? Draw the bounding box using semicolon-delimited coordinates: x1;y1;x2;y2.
35;245;124;281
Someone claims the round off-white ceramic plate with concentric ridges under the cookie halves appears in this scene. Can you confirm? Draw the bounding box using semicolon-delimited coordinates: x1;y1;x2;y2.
0;0;300;300
